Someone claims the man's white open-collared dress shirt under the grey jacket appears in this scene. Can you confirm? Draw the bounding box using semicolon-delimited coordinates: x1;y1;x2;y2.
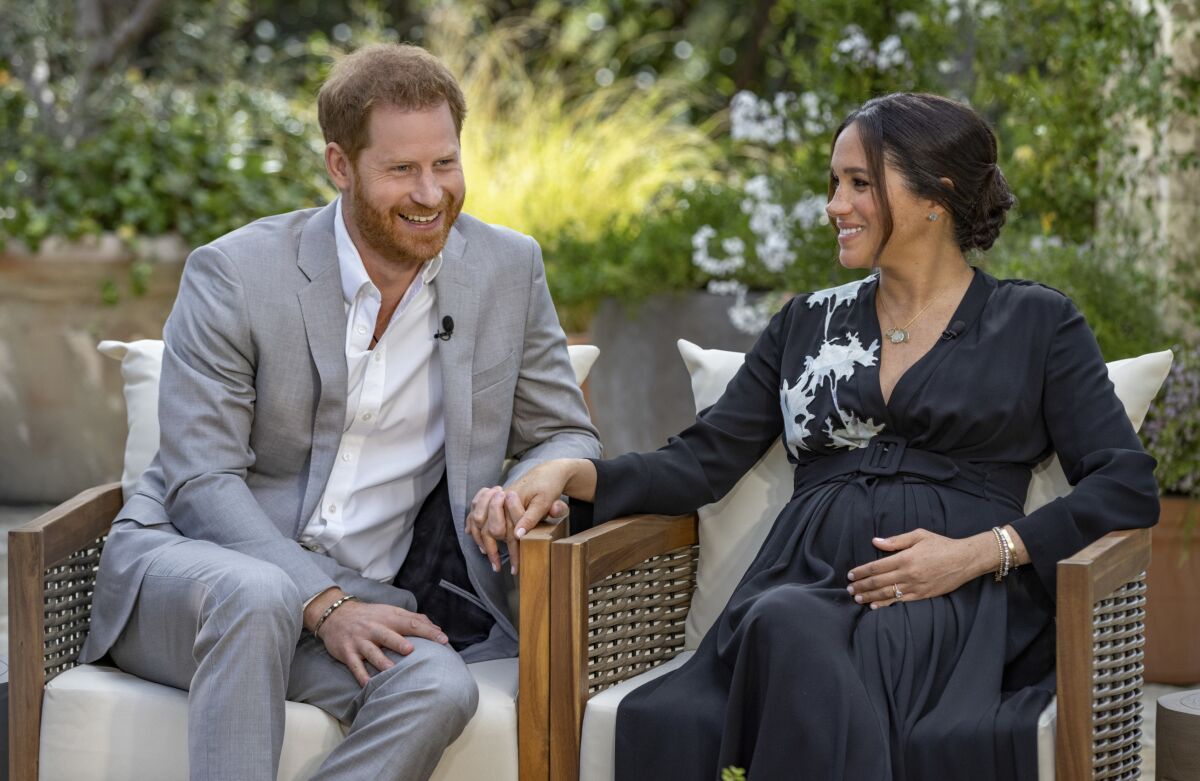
300;199;445;581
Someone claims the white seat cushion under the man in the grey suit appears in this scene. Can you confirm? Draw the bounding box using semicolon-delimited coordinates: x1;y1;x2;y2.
40;659;517;781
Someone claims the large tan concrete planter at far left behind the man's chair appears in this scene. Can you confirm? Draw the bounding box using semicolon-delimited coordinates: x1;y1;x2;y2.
0;242;184;504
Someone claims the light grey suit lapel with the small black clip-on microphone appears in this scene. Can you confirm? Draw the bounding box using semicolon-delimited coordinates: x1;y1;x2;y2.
433;228;479;525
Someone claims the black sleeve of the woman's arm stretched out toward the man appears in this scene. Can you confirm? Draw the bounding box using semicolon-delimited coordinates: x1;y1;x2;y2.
594;299;797;523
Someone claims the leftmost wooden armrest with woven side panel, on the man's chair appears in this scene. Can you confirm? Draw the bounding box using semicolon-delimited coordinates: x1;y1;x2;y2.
8;482;121;779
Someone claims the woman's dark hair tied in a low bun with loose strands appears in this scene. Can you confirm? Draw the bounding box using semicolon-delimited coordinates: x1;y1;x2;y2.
829;92;1016;257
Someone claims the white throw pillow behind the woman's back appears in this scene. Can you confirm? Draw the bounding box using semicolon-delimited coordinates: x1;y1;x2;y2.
678;340;1171;649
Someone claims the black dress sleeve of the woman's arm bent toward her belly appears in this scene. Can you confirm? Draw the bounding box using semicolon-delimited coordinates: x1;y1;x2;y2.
1013;299;1158;597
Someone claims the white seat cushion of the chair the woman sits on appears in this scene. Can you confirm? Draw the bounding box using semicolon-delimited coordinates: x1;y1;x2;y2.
580;650;1058;781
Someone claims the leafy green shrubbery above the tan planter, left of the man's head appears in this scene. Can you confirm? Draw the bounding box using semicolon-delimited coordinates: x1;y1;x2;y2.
0;0;330;248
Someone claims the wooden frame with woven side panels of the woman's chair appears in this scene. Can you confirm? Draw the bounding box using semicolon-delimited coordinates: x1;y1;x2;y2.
550;515;1150;781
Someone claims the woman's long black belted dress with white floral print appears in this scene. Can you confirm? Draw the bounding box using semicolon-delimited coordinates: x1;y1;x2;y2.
594;270;1158;781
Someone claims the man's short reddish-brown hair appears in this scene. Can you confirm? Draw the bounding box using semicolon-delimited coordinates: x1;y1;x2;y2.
317;43;467;160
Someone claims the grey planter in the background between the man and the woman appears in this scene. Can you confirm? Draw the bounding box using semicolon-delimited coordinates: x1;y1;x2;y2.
588;293;756;457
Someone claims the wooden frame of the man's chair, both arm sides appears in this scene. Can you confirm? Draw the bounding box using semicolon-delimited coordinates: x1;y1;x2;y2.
8;483;566;781
